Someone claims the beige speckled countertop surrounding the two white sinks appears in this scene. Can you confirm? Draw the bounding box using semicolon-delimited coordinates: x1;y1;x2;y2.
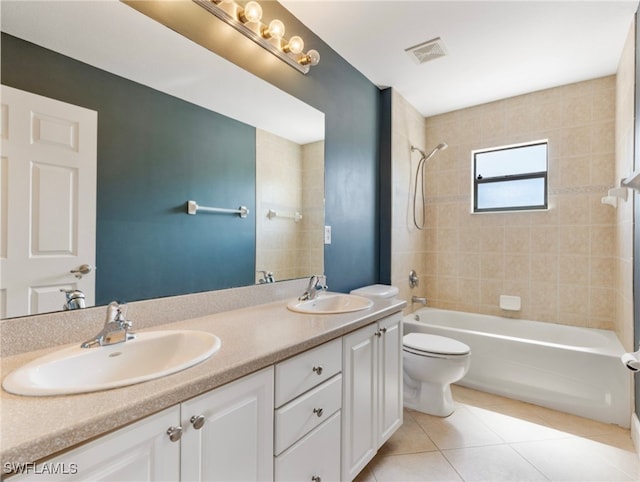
0;300;406;467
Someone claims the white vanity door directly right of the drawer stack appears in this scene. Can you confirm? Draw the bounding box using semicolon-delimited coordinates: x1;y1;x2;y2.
342;323;378;481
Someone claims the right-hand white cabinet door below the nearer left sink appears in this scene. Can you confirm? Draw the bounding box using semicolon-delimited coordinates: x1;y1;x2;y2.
181;367;273;481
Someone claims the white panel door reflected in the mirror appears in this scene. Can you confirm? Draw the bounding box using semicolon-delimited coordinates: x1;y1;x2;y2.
0;86;98;317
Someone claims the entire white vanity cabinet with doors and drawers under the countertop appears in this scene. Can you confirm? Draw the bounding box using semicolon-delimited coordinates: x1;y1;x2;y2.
4;312;402;482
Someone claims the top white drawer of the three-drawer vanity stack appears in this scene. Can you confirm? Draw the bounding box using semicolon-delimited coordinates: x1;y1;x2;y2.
275;338;342;407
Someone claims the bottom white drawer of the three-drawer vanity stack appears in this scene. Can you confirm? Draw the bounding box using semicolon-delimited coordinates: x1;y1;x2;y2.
274;411;340;482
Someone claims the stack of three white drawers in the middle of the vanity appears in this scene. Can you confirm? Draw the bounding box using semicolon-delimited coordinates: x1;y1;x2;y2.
274;339;342;482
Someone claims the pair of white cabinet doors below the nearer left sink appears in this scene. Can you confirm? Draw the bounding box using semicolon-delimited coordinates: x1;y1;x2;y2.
10;366;273;482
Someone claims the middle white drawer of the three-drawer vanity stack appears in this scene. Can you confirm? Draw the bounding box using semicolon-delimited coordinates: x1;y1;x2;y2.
274;375;342;455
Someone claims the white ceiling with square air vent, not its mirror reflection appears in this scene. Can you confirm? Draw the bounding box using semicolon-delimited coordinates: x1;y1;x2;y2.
280;0;638;116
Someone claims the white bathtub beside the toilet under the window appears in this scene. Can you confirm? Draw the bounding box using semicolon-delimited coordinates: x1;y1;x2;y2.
404;308;631;427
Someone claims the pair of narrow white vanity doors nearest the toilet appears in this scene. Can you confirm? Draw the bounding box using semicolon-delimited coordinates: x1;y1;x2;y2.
342;313;402;481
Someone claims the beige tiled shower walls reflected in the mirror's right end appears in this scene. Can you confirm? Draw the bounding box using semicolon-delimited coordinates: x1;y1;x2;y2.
256;129;324;283
